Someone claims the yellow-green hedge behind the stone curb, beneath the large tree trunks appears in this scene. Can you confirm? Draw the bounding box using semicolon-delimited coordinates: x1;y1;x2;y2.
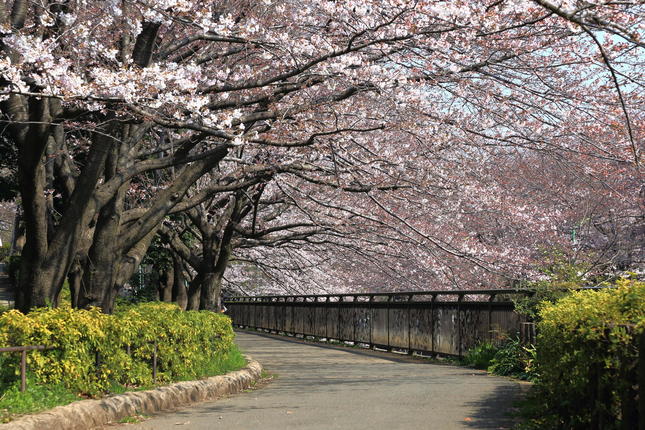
0;303;234;394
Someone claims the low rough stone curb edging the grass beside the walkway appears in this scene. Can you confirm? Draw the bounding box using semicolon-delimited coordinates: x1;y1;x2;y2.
0;356;262;430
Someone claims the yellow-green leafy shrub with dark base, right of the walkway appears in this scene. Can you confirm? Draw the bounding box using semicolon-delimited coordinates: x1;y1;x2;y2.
537;279;645;429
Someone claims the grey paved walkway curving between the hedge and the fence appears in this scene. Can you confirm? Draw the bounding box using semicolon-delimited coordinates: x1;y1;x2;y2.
127;332;521;430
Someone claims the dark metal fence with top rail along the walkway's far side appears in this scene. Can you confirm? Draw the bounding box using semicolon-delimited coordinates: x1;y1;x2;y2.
225;290;533;356
